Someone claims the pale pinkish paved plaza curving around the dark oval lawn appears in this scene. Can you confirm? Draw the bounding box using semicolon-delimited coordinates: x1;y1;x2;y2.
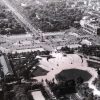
35;52;100;95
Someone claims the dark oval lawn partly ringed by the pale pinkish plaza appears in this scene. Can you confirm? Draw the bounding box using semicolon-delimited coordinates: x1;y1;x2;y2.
56;69;92;81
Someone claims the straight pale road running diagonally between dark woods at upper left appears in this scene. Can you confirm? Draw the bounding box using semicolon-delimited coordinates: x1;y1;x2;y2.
2;0;40;36
